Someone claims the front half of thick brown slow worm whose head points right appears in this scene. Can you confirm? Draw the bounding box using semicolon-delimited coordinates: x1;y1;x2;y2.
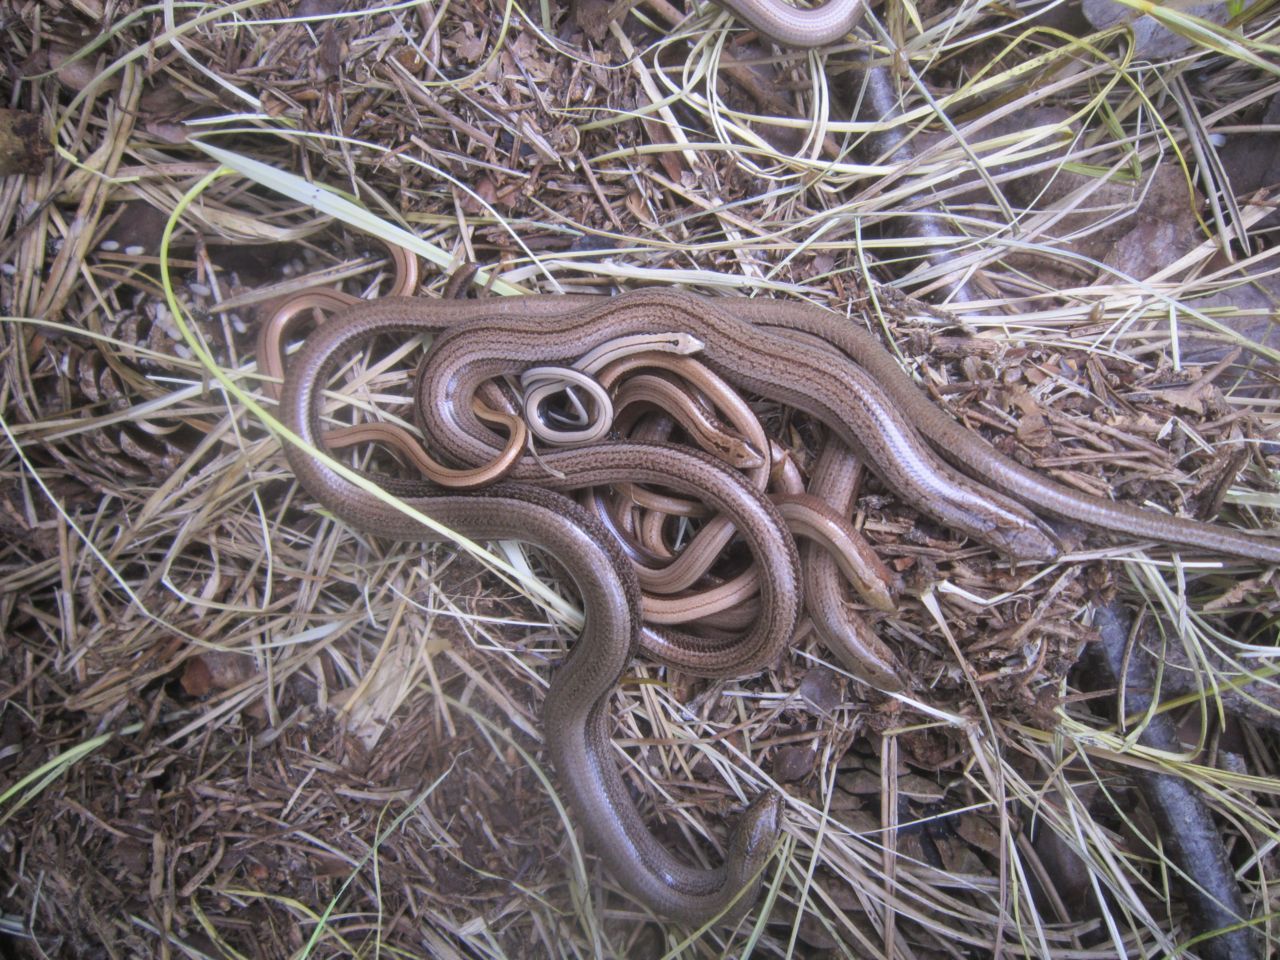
417;289;1057;559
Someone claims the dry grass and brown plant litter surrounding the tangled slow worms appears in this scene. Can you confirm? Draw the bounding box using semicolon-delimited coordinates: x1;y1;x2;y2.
0;0;1280;957
